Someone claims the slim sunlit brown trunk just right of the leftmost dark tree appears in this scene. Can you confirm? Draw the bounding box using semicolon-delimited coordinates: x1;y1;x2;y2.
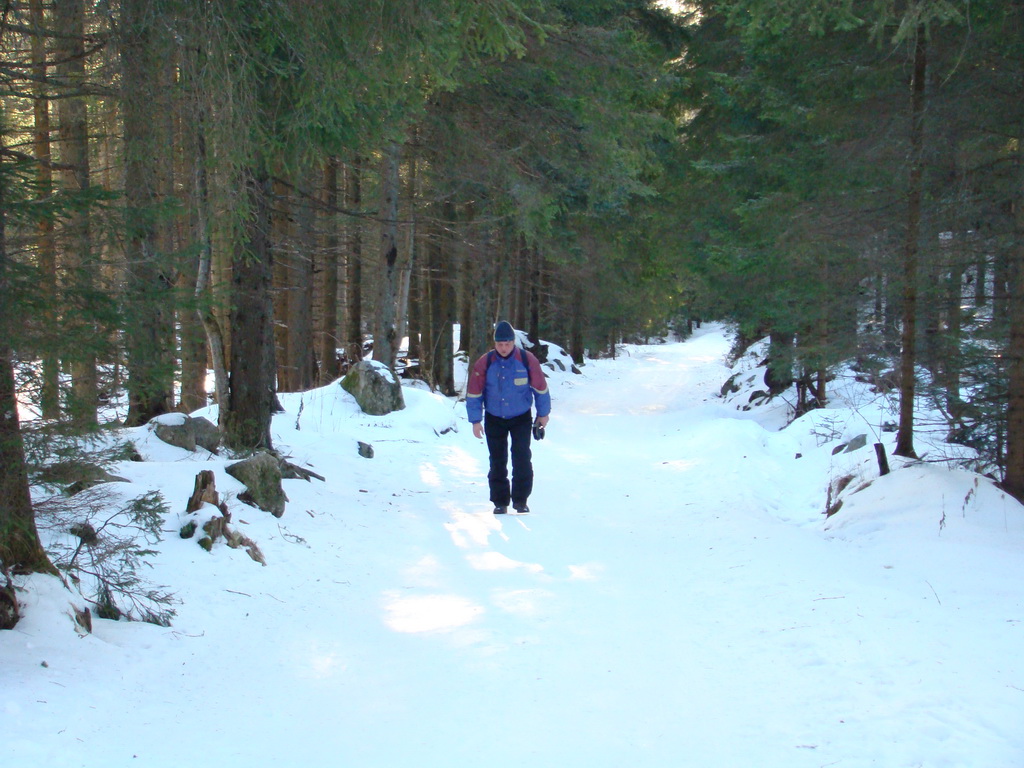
29;0;60;419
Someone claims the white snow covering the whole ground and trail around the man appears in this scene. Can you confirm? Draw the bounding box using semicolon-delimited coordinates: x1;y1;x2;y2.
0;326;1024;768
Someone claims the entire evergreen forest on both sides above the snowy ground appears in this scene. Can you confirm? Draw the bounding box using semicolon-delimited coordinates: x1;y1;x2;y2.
0;0;1024;581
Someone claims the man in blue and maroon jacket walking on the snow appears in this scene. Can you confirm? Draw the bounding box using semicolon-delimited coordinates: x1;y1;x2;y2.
466;321;551;515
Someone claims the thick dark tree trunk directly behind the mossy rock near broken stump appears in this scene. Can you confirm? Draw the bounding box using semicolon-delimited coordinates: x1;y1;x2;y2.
221;163;274;452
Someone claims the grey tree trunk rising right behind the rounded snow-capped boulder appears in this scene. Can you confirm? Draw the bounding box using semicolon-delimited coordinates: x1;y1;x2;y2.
374;141;401;369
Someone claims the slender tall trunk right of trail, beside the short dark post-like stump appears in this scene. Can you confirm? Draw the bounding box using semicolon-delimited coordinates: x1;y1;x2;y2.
893;26;928;458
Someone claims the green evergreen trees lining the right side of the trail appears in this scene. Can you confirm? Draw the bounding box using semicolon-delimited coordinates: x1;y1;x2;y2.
676;0;1024;487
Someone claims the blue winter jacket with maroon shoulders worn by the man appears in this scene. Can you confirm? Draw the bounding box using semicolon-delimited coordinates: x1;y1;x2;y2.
466;347;551;424
